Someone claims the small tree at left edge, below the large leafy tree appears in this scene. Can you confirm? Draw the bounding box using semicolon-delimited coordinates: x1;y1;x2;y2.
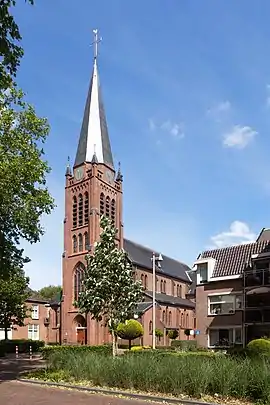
0;269;29;340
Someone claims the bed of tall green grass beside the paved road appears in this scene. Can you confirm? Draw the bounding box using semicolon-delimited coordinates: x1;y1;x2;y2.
28;351;270;404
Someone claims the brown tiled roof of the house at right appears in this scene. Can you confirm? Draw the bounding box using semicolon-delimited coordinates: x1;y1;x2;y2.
200;240;270;277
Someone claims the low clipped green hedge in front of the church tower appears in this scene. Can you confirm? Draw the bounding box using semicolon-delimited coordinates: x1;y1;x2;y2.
41;345;112;359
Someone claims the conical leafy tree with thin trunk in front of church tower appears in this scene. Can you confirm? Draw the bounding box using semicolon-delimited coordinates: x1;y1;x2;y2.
76;216;142;356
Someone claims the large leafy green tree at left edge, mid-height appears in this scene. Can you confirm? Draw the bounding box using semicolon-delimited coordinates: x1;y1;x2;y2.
0;87;54;275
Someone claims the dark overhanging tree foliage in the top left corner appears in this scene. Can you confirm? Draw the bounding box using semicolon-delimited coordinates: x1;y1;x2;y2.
0;0;34;91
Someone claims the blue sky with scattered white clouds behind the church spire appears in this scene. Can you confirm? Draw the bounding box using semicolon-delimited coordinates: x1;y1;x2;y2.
15;0;270;288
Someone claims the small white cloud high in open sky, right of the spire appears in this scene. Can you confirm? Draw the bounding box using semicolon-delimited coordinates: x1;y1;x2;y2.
223;125;258;149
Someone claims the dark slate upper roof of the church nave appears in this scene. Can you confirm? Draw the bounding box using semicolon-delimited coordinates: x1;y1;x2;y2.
124;239;191;283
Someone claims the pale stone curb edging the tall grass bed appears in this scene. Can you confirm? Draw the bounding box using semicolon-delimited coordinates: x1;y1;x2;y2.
17;378;221;405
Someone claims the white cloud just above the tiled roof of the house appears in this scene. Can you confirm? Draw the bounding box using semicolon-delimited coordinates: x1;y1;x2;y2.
211;221;256;249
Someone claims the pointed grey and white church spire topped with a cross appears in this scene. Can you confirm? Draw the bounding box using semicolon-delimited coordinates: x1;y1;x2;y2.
74;30;114;168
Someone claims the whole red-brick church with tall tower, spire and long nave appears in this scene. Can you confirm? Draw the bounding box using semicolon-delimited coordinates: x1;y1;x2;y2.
61;36;195;345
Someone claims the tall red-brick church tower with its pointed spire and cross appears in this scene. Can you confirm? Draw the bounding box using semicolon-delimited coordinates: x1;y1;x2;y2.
62;30;123;344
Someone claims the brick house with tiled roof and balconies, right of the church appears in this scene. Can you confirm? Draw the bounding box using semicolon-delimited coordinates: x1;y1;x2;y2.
193;228;270;348
